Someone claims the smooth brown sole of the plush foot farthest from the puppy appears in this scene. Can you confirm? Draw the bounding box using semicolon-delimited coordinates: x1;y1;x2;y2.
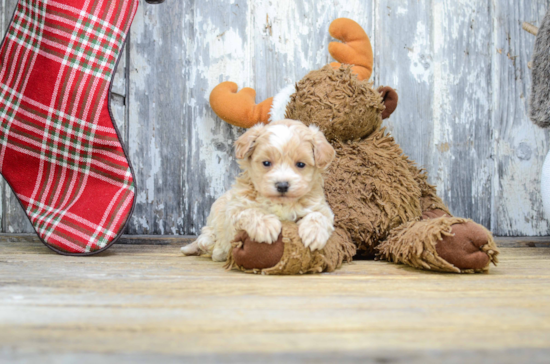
435;221;498;270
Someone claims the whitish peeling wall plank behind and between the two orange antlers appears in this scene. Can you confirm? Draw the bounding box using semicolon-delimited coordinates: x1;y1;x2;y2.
252;0;375;100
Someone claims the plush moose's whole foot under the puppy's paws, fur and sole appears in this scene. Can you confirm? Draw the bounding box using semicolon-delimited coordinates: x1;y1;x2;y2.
226;222;355;275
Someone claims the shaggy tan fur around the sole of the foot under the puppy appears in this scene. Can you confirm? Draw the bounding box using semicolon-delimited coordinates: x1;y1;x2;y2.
225;222;355;275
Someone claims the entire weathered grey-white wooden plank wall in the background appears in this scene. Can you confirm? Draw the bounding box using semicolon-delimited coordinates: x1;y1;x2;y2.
0;0;550;235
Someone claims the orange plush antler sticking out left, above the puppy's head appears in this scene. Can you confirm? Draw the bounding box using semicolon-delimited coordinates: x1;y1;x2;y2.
210;82;273;128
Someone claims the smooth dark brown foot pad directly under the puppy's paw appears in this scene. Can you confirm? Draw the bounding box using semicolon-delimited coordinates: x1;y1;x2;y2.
232;231;284;269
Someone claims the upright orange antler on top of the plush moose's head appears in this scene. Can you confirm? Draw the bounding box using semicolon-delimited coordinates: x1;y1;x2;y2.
328;18;373;80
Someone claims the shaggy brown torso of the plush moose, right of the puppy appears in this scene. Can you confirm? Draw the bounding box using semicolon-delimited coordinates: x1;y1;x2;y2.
325;129;422;252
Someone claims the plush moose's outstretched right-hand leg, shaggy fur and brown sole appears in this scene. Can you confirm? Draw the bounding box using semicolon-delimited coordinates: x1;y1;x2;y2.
378;210;498;273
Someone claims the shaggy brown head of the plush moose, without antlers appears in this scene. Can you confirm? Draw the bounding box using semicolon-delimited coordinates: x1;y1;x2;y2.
285;65;385;142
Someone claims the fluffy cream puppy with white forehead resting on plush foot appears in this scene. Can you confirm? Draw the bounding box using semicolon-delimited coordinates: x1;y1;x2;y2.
181;120;335;261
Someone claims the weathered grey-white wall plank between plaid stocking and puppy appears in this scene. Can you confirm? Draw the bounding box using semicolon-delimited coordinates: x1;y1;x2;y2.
129;1;251;234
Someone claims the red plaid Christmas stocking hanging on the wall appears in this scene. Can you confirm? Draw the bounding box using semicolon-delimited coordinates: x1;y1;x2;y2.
0;0;146;255
